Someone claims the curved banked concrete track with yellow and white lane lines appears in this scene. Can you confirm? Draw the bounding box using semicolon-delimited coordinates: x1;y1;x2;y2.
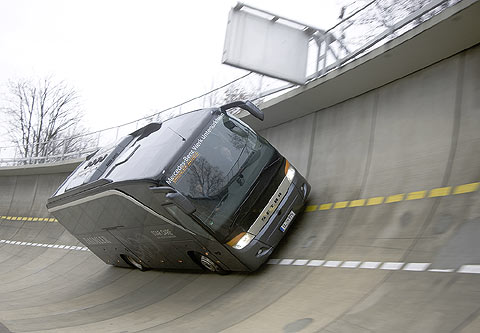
0;1;480;333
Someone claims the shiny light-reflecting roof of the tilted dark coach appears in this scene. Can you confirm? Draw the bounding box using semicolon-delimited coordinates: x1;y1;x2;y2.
55;109;217;196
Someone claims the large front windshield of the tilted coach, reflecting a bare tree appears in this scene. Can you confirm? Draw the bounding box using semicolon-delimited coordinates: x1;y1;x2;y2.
165;114;275;242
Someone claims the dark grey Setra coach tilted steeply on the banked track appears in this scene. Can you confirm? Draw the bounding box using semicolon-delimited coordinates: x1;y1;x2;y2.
47;101;310;273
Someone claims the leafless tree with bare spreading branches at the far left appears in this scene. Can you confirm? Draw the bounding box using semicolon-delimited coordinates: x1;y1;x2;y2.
1;77;91;162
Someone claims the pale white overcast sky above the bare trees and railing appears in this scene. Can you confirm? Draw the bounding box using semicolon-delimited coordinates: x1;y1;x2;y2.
0;0;345;137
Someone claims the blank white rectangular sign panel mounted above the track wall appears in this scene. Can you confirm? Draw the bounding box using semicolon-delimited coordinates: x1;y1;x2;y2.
222;9;310;84
